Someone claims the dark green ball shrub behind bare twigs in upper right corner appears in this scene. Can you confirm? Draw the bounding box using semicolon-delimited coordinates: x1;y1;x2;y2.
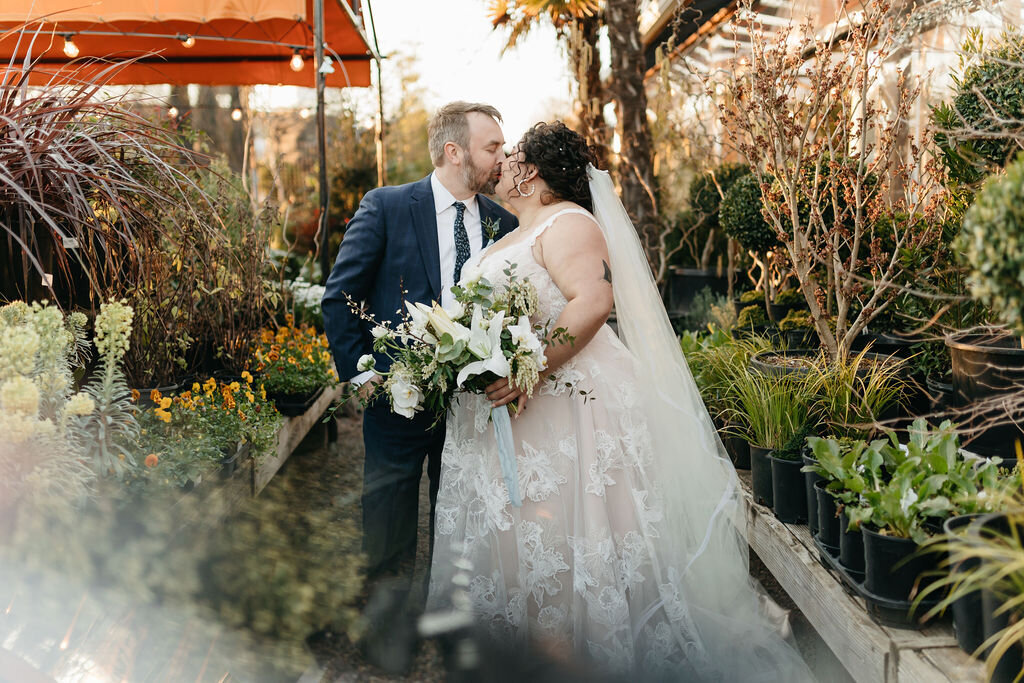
932;31;1024;183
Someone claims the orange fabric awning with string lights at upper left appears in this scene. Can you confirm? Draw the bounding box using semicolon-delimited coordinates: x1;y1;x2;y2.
0;0;373;87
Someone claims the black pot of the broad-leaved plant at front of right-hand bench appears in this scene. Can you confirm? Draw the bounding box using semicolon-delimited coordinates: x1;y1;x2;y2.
861;526;938;600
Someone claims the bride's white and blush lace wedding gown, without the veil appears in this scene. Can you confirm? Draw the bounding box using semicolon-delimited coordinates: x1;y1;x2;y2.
427;209;800;681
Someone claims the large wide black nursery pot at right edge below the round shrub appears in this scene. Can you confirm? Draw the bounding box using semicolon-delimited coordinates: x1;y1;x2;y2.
946;333;1024;457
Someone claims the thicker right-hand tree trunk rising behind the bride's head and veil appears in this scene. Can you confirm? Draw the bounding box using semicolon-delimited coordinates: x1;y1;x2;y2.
605;0;657;263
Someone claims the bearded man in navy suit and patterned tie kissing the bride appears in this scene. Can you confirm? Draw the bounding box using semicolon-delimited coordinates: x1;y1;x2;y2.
323;101;517;590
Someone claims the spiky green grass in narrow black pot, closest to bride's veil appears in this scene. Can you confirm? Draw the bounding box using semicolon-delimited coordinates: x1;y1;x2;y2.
733;362;814;508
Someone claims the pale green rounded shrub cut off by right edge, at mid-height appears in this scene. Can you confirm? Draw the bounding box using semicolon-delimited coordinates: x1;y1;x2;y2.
958;156;1024;334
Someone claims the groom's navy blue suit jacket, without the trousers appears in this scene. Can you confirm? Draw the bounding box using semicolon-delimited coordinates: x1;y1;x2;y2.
323;176;518;379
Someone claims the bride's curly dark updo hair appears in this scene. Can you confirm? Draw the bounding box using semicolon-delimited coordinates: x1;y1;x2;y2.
513;121;597;211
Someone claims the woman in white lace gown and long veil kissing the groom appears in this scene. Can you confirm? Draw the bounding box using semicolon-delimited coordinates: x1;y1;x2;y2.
427;123;811;681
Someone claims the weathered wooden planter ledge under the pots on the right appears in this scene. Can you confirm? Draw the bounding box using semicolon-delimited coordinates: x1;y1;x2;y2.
739;472;985;683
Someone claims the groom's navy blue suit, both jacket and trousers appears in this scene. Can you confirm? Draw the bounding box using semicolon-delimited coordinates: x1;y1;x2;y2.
323;176;518;582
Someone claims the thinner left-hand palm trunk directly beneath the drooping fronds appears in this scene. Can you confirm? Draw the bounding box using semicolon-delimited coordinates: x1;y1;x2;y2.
567;15;609;169
